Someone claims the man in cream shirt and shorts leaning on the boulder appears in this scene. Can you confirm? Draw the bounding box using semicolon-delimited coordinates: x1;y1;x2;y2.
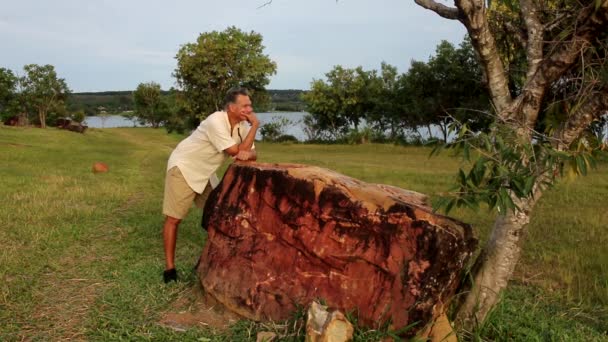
163;88;260;283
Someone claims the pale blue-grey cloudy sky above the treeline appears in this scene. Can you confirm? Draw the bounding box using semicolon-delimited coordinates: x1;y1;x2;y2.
0;0;465;92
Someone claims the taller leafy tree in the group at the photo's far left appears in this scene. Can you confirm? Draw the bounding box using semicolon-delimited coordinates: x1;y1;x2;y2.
20;64;70;128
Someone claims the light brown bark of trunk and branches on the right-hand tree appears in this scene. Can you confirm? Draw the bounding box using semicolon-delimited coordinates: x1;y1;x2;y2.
416;0;608;329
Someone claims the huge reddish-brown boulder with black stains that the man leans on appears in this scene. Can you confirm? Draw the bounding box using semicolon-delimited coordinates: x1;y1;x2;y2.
198;162;476;336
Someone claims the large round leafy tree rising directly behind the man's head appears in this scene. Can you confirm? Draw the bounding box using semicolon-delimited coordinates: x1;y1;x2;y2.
174;27;276;127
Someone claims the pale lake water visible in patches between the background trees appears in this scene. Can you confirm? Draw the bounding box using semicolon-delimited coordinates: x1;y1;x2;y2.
84;112;441;141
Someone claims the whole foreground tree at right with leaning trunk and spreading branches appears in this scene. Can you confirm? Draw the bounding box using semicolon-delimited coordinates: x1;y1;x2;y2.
415;0;608;326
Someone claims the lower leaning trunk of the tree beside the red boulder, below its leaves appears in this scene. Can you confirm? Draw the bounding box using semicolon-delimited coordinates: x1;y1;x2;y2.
456;186;542;331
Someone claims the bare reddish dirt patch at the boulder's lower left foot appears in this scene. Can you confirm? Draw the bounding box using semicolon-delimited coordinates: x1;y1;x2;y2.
159;286;243;331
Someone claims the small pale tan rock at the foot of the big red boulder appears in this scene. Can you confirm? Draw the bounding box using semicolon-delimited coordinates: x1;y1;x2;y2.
306;301;354;342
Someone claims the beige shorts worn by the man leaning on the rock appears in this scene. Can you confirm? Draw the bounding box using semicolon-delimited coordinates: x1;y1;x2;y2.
163;166;212;220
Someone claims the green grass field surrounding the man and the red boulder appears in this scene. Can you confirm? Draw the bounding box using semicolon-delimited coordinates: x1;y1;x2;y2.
0;127;608;341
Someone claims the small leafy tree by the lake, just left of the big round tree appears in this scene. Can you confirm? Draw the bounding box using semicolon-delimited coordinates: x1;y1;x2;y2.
133;82;170;128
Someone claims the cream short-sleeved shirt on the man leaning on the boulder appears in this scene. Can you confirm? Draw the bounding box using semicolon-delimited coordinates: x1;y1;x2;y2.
167;111;249;194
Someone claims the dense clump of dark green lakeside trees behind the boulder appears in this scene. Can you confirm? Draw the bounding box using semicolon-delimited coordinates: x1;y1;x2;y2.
303;40;491;140
